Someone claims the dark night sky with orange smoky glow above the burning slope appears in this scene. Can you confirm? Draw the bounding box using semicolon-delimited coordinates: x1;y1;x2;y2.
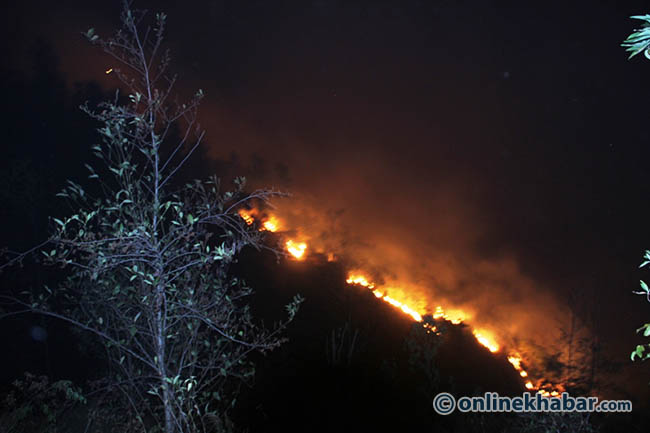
3;0;650;398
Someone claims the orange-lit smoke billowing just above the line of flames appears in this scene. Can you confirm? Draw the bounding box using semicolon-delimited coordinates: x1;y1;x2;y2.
200;118;566;358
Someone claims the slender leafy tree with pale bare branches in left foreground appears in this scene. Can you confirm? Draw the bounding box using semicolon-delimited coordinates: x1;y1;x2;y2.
1;2;301;433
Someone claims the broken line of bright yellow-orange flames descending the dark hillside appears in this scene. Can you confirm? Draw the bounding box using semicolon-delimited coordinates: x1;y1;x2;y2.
239;209;564;397
